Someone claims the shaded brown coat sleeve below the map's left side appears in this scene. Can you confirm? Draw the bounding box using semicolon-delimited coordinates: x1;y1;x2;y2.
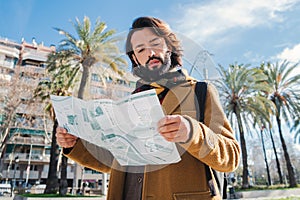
63;139;113;173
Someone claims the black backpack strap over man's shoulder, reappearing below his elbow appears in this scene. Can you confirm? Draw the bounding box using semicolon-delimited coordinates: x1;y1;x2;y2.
195;81;219;196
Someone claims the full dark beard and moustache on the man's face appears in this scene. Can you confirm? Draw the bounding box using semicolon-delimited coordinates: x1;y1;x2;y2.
133;53;171;82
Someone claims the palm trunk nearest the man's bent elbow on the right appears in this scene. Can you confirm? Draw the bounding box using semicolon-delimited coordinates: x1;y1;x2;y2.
235;112;249;189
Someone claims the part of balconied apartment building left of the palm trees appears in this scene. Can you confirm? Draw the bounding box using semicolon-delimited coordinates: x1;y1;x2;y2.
0;39;55;189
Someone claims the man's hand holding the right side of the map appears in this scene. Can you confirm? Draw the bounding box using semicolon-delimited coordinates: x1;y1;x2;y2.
158;115;191;142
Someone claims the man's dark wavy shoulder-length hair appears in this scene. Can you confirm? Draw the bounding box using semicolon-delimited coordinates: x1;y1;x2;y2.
126;17;183;68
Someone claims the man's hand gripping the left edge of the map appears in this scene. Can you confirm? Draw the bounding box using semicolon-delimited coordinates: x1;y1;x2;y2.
56;127;77;148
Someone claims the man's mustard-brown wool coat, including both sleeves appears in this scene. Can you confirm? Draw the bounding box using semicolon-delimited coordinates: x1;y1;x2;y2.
66;81;240;200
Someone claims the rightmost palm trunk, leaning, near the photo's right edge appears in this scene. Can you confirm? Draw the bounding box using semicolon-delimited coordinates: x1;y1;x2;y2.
276;115;297;187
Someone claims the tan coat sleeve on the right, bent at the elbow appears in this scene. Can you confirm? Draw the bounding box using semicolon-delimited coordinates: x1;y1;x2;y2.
180;84;240;172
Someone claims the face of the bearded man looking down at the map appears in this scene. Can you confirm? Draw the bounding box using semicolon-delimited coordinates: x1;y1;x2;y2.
131;28;170;70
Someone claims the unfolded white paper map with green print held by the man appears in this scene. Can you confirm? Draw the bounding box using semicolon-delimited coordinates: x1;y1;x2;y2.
51;89;180;166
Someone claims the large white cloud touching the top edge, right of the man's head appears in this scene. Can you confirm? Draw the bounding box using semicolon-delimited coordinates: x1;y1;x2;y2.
175;0;300;42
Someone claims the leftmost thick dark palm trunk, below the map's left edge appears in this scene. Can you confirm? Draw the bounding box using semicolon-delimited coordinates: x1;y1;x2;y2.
44;119;59;194
